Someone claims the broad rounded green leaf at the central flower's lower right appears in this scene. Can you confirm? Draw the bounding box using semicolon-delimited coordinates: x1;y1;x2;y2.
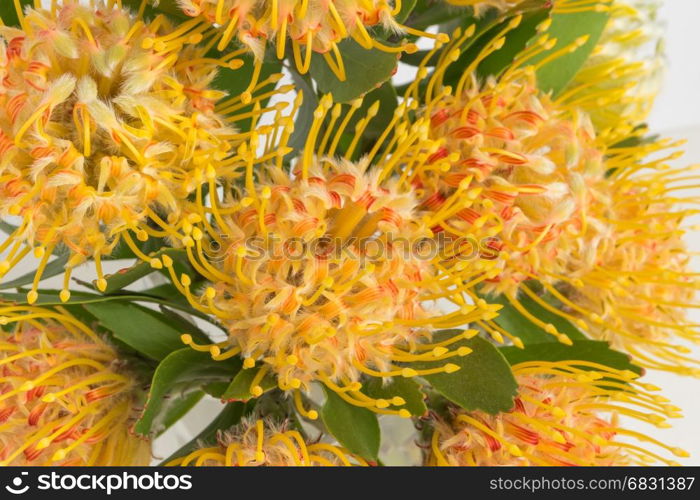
410;330;518;415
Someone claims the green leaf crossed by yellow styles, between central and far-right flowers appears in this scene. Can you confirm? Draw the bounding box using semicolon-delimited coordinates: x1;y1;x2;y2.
484;288;586;345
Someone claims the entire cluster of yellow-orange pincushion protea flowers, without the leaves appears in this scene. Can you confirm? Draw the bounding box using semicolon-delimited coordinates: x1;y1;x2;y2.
0;0;700;466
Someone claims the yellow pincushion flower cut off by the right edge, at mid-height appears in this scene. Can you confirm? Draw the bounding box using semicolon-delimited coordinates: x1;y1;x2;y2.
546;156;700;376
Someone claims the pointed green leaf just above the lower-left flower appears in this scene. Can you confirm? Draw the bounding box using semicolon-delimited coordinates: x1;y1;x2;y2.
85;301;208;360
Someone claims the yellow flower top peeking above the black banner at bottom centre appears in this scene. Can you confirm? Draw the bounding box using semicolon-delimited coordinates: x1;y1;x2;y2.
167;420;368;467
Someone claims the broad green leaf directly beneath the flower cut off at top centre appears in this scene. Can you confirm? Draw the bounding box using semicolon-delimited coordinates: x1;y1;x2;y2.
311;38;398;102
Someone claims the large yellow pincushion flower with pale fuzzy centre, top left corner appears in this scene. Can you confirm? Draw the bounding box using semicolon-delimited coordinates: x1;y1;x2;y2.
0;0;278;302
